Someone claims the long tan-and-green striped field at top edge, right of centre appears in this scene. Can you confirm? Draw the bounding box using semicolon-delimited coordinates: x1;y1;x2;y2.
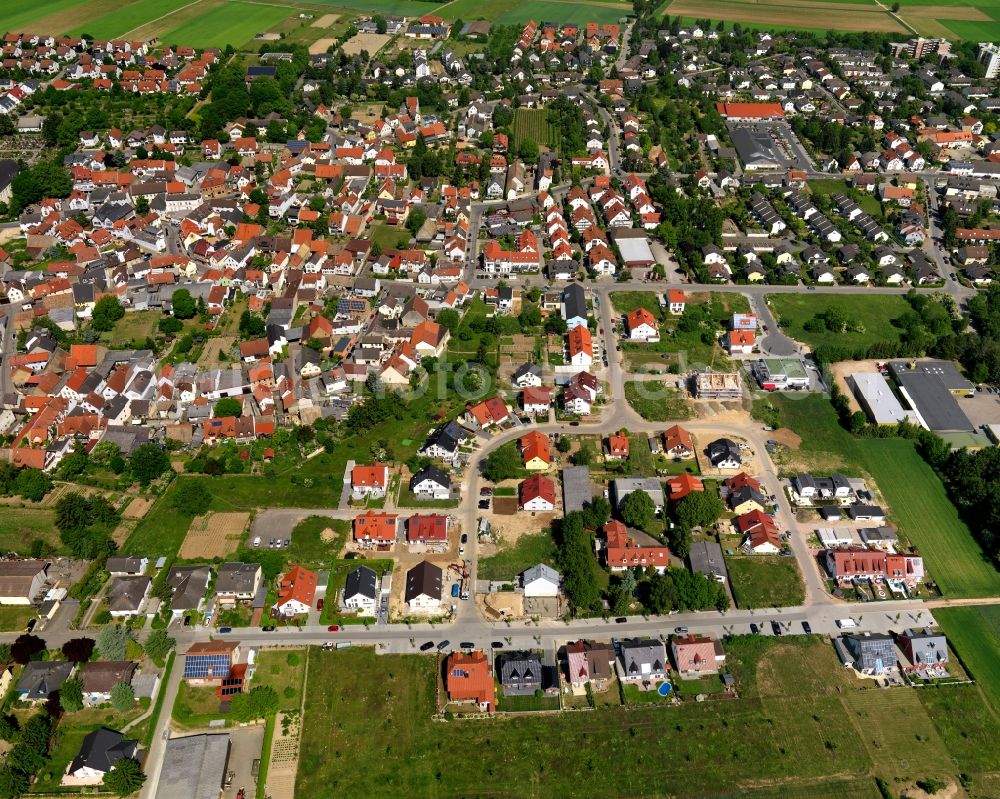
667;0;904;33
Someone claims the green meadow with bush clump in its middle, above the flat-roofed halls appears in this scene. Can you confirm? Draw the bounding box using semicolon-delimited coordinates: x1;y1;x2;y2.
766;293;910;350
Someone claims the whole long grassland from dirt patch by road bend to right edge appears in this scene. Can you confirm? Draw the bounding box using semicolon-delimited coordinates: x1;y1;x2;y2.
767;394;1000;598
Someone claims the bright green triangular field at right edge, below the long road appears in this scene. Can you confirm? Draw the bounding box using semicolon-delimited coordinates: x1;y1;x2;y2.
934;605;1000;712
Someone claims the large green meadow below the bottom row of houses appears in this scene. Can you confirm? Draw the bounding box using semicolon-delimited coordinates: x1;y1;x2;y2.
296;636;976;797
